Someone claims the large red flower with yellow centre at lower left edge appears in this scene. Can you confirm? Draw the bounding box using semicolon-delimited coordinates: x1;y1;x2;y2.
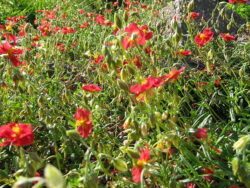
0;122;34;146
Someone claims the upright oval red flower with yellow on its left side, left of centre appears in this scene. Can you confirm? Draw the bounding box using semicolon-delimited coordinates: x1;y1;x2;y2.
75;108;92;138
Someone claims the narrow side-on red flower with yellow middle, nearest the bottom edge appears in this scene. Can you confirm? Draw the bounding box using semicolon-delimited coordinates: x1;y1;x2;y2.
132;147;150;183
